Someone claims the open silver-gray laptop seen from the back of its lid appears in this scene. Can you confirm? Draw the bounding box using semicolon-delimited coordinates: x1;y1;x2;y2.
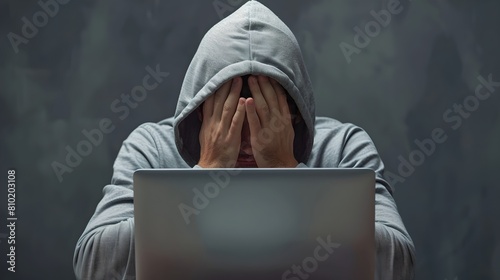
134;168;375;280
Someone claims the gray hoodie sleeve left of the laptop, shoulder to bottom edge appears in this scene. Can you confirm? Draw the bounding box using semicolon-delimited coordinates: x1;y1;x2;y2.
73;124;158;280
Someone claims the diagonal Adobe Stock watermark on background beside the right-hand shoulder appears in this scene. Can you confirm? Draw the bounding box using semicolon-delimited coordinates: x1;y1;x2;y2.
384;74;500;187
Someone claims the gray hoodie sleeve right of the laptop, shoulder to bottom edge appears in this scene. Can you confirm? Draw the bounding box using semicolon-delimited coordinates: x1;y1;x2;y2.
339;125;415;280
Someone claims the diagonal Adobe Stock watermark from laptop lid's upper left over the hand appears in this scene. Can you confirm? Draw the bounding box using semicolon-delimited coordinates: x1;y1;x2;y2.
178;108;293;225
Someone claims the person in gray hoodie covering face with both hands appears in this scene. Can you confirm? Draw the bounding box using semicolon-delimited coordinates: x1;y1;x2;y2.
73;1;415;280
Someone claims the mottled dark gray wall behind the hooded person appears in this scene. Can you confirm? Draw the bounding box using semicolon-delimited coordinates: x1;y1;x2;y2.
0;0;500;280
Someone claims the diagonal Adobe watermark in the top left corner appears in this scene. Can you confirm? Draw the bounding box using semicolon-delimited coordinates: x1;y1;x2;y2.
7;0;70;54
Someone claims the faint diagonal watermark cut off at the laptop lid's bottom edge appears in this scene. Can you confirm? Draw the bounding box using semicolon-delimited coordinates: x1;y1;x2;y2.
281;235;340;280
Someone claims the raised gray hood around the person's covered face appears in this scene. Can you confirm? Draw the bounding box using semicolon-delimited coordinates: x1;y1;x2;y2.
174;1;315;166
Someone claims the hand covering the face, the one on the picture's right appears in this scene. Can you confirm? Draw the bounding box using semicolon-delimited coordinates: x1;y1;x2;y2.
245;76;298;168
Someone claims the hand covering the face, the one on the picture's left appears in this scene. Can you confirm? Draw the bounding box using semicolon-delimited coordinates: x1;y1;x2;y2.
198;77;245;168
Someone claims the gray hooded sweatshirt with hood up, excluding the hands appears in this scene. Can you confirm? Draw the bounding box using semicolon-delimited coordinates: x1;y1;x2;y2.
73;1;415;280
